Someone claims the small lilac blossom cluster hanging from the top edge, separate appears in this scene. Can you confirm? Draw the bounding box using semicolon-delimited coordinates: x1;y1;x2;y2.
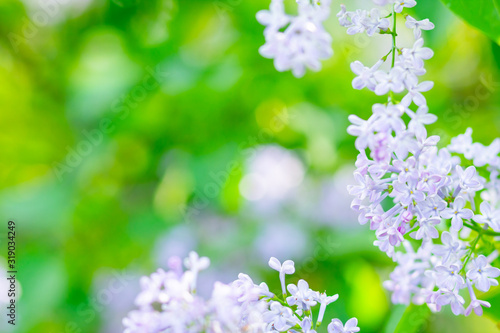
257;0;333;77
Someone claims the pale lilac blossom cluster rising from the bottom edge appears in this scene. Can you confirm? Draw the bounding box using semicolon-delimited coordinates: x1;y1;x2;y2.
123;252;359;333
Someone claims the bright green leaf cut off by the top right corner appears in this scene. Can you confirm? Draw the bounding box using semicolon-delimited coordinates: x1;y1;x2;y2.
441;0;500;44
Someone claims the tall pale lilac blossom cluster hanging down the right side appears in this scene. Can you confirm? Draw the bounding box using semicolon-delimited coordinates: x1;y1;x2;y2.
338;0;500;315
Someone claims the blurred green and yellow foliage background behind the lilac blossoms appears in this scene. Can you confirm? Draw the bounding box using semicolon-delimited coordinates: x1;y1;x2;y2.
0;0;500;333
